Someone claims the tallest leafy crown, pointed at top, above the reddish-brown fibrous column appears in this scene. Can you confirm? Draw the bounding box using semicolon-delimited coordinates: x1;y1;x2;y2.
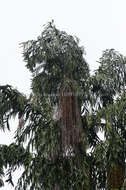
23;23;89;103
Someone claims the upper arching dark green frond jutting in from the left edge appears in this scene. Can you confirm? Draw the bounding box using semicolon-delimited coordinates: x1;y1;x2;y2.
0;85;27;129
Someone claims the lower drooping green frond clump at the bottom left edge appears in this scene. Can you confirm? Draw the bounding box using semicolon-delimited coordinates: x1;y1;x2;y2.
0;143;32;186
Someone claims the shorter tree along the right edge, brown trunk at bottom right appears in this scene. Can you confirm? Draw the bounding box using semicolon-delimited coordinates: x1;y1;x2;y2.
93;49;126;189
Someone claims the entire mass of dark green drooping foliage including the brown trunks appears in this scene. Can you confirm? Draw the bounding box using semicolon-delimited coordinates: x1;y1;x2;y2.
0;22;126;190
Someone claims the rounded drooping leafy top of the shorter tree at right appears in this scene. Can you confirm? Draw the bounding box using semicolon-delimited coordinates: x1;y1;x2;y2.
92;49;126;107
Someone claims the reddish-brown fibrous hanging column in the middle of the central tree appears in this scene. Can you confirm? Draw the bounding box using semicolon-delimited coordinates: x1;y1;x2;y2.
59;79;82;156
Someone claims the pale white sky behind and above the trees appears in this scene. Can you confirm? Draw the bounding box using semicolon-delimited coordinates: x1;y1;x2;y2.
0;0;126;190
